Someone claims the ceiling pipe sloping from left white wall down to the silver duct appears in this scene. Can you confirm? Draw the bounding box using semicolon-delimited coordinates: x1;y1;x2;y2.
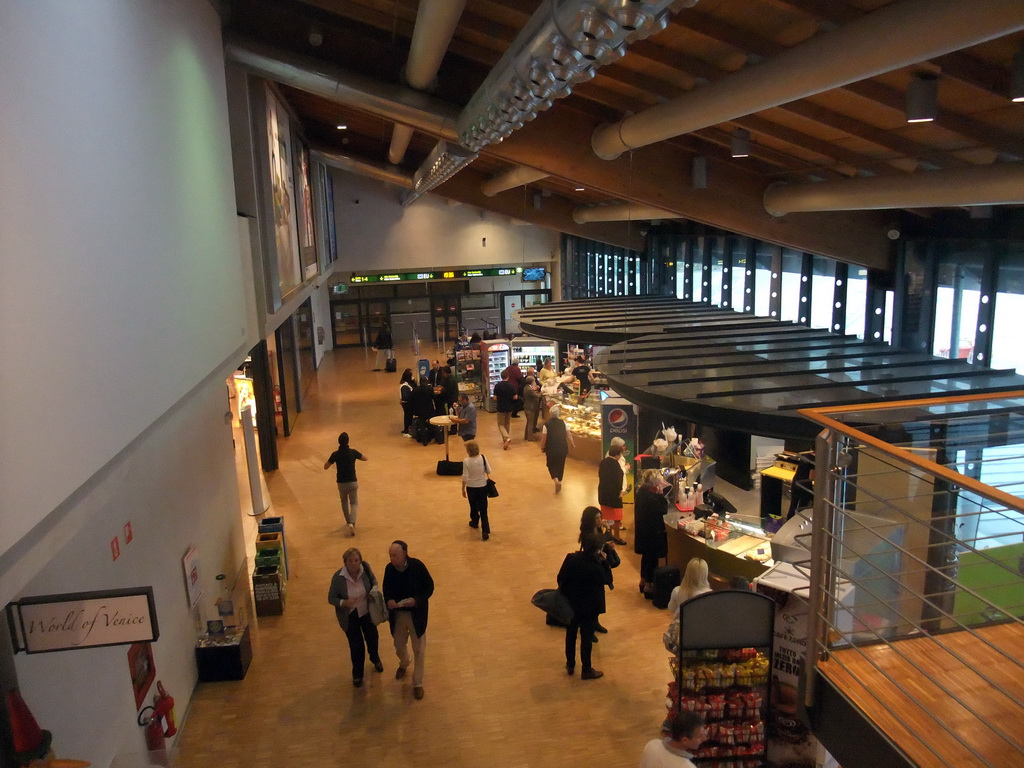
230;37;459;140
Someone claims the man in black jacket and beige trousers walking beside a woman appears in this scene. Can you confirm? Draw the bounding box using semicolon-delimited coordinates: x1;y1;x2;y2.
384;541;434;699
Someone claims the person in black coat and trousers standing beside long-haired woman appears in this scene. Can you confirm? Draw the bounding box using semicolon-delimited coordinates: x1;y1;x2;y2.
558;531;611;680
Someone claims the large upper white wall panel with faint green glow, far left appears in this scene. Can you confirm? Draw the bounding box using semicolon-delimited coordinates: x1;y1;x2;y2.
0;0;256;565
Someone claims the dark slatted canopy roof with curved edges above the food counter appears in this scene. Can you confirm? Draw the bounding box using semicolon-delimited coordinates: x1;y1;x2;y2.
516;297;1024;438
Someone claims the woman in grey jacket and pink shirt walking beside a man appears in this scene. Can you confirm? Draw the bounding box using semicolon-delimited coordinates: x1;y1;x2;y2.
327;547;387;688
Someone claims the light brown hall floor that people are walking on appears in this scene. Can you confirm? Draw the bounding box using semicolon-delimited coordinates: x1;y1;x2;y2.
176;350;752;768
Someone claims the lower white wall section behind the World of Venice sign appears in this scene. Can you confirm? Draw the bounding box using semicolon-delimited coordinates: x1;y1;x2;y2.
15;377;245;766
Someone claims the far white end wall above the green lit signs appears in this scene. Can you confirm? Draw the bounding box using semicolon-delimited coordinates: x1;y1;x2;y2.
332;169;558;274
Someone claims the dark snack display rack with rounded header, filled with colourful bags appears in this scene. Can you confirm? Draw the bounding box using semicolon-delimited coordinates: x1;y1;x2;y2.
669;590;775;768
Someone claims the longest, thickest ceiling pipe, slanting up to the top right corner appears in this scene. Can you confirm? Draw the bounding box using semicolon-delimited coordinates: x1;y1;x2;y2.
591;0;1024;160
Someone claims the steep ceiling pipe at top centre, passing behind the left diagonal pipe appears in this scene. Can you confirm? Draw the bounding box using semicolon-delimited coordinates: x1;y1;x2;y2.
387;0;466;165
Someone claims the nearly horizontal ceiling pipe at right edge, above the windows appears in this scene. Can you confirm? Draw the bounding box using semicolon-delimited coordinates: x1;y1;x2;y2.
764;163;1024;216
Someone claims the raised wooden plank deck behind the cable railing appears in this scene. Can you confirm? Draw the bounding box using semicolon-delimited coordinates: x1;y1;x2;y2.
818;624;1024;768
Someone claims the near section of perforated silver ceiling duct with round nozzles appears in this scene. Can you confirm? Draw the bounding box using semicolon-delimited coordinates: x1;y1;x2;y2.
458;0;697;152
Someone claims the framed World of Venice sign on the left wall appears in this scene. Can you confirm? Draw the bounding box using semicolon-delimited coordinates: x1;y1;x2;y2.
7;587;160;653
